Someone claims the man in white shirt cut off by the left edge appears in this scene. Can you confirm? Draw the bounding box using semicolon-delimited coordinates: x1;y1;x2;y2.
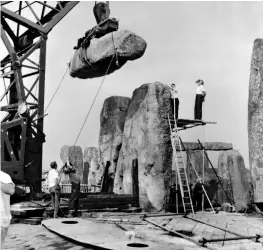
0;171;15;249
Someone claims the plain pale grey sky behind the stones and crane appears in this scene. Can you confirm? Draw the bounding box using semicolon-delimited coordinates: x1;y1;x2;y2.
1;1;263;169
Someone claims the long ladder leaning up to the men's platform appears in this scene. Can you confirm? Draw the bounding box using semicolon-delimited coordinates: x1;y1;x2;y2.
168;115;194;213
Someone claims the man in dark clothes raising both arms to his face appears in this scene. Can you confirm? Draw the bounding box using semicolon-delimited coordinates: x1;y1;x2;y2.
63;162;80;217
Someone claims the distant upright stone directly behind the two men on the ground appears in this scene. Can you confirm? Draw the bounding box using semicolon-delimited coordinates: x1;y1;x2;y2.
60;146;83;180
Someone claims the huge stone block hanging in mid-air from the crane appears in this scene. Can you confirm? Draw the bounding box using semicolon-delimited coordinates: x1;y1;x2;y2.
69;30;147;79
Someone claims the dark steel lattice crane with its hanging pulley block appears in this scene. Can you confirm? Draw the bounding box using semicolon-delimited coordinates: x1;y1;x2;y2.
1;1;117;192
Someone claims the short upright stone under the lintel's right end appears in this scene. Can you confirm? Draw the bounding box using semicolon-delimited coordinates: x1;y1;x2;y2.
218;150;255;211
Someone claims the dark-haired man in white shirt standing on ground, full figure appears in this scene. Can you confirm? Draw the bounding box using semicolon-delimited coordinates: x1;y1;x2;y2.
48;161;61;218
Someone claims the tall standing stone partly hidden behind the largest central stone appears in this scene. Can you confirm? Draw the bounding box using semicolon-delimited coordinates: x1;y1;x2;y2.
99;96;131;191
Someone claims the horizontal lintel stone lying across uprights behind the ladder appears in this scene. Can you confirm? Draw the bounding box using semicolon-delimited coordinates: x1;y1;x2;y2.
179;142;233;151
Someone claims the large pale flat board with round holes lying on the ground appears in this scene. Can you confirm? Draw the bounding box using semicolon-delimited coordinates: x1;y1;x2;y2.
42;218;177;250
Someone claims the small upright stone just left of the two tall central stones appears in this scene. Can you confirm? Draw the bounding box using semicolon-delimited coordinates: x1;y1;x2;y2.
84;147;103;191
